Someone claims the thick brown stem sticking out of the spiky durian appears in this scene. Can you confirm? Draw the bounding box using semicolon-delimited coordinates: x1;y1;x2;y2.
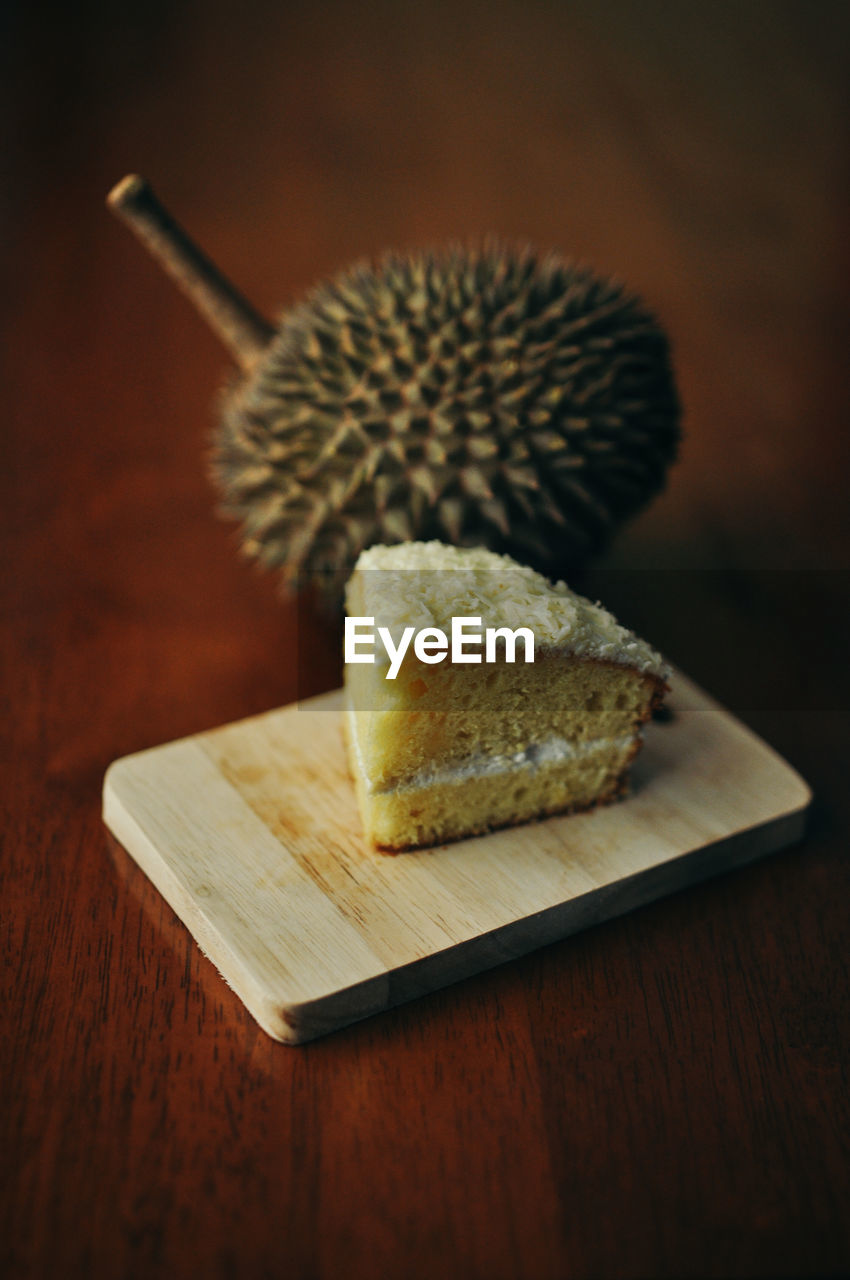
106;174;274;371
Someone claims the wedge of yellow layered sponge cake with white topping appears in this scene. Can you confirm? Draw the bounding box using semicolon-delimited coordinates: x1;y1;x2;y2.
344;543;667;850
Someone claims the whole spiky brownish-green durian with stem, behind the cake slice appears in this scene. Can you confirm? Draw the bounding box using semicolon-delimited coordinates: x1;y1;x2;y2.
110;178;680;590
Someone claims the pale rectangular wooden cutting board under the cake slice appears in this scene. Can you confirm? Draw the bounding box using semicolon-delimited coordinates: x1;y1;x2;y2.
104;675;810;1044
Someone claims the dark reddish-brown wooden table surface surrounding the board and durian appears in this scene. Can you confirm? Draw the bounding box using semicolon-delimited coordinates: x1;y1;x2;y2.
0;0;850;1280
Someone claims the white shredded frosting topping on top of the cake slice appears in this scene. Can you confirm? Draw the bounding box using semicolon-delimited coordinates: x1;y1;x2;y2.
349;541;668;678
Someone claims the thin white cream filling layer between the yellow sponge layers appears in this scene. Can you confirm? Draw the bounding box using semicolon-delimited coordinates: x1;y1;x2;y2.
347;707;635;795
